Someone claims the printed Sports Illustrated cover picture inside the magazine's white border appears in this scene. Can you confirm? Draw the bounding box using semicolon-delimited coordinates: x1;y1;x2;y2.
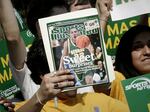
47;16;108;86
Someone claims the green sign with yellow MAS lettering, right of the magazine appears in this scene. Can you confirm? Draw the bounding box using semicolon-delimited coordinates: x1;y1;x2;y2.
104;15;150;60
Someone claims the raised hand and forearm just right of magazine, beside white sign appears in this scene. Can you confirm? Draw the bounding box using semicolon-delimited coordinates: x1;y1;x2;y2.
96;0;112;33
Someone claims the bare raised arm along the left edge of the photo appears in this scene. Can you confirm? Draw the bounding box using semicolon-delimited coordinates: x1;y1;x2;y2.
0;0;26;69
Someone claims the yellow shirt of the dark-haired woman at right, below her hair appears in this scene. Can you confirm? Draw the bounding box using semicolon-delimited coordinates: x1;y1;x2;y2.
110;71;127;104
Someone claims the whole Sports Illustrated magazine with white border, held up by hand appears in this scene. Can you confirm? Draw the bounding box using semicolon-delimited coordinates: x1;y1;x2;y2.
39;8;114;91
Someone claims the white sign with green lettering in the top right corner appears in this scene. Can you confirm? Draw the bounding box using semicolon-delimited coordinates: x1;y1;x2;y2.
111;0;150;21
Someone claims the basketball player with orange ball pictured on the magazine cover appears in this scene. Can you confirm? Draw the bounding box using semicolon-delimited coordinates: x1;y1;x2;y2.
59;28;94;70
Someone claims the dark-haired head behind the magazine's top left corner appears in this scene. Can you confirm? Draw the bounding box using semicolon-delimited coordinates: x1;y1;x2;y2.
27;0;69;36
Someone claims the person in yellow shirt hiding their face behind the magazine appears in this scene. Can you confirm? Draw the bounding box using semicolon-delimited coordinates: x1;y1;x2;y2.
15;39;129;112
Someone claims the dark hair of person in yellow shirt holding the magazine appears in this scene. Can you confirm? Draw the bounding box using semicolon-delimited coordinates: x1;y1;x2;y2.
27;39;50;84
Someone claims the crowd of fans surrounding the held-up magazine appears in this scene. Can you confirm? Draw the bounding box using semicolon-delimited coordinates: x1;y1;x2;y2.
0;0;150;112
